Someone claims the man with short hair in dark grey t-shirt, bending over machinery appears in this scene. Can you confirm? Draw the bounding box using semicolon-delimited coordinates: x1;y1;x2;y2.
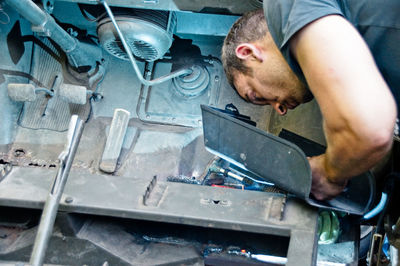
222;0;400;200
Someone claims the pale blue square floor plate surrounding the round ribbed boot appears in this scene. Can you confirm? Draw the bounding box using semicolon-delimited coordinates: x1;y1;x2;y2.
138;57;223;127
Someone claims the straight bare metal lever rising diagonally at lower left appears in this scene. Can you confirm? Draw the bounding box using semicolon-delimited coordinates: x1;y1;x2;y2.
30;115;83;266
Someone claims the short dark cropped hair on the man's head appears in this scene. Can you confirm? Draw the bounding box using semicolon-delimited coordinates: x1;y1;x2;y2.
222;9;268;87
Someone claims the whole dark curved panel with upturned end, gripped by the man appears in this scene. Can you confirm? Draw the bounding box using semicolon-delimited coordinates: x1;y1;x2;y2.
201;105;375;215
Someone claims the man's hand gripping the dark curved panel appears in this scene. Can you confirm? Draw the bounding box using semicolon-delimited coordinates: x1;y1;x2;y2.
308;155;347;200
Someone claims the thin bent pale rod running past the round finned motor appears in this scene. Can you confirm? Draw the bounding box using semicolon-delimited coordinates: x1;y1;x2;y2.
99;0;192;86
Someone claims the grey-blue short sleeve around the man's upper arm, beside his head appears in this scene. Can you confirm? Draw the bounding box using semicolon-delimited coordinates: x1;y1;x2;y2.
264;0;344;83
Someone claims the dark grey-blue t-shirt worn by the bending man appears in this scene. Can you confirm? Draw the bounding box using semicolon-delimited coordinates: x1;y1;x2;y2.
264;0;400;116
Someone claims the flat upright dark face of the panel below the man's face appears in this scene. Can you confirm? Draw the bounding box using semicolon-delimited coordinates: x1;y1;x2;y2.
201;105;311;198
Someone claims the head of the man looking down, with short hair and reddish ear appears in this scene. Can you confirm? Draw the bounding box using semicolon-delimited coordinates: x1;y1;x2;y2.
222;9;312;115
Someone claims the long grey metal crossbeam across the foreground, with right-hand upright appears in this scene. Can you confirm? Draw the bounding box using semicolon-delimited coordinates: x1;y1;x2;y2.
0;167;317;265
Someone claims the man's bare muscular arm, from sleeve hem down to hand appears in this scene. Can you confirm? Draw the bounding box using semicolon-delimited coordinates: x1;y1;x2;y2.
290;15;396;199
